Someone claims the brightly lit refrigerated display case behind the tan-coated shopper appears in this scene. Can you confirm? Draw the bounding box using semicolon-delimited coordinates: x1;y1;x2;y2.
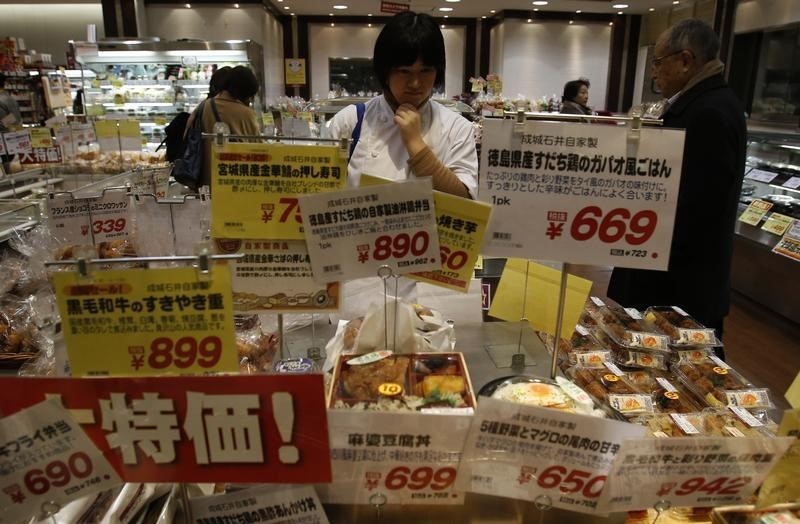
70;39;264;148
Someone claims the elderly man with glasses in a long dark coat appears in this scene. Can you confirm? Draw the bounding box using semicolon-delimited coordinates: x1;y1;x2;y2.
608;20;746;356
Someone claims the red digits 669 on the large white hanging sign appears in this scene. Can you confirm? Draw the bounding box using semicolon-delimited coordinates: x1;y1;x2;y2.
570;206;658;246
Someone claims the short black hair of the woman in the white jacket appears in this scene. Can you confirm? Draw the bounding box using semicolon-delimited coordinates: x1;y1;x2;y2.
372;11;445;90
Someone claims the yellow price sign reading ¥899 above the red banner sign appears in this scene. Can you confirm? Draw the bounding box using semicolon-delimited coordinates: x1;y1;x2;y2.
53;265;238;376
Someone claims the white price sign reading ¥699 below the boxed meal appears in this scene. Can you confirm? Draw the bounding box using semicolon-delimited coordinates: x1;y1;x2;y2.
317;409;472;505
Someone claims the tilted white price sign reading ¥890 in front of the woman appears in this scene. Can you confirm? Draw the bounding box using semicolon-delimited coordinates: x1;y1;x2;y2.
300;178;441;282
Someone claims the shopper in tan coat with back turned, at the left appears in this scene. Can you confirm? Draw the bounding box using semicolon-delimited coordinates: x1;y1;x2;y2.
186;66;261;186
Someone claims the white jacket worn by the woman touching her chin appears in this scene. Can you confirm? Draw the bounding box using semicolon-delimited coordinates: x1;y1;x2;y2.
328;95;478;198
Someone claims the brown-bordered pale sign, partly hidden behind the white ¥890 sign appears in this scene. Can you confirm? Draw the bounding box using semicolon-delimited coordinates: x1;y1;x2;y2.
216;239;339;313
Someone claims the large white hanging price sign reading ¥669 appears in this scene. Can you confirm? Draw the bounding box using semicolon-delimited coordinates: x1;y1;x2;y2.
479;120;684;270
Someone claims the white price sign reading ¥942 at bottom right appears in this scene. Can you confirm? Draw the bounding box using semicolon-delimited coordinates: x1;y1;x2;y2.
600;437;794;512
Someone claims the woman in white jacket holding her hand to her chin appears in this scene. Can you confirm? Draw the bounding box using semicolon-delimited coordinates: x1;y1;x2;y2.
328;11;478;198
